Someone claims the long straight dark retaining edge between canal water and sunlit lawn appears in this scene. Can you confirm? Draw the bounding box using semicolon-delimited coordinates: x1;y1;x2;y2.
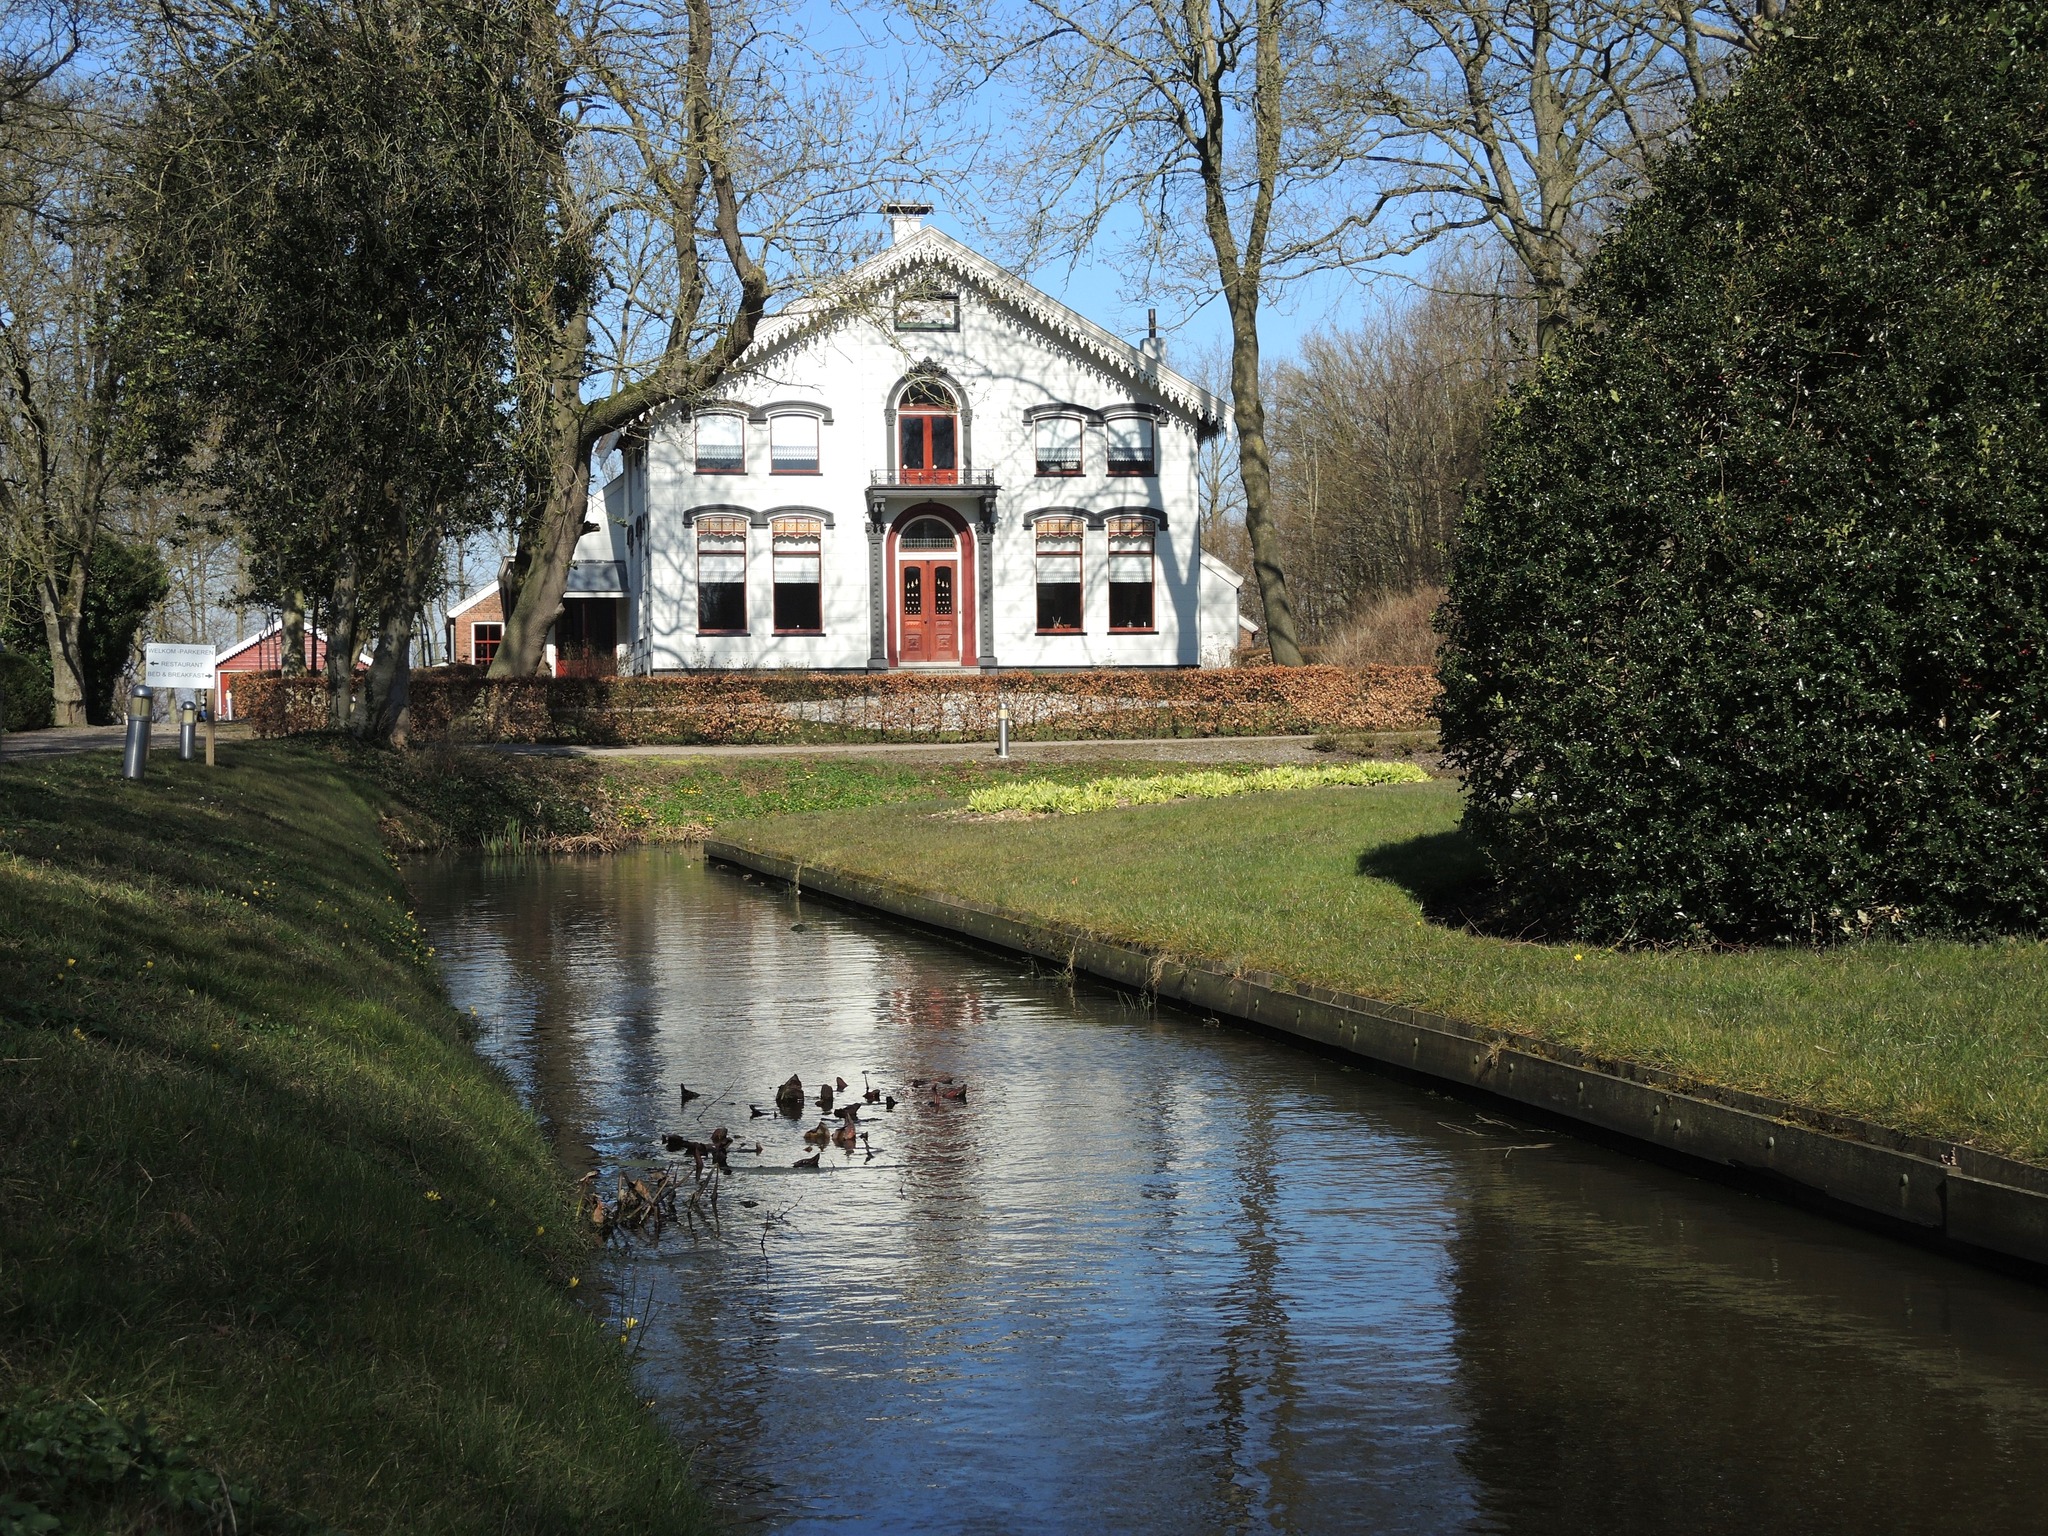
705;838;2048;1278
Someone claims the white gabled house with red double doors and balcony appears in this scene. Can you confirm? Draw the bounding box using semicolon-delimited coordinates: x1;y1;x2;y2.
581;203;1243;672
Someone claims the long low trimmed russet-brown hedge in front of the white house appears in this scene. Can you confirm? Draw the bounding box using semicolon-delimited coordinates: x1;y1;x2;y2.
236;668;1436;745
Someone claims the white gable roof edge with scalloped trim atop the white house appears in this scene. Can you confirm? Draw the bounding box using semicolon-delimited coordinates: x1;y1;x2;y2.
733;225;1227;436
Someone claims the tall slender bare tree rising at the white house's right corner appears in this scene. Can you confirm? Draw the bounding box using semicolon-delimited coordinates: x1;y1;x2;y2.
911;0;1380;666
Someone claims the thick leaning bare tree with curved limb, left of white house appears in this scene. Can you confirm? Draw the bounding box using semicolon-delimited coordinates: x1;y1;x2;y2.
492;0;907;676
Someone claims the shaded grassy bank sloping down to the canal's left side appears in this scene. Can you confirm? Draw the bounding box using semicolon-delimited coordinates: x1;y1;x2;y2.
0;745;702;1532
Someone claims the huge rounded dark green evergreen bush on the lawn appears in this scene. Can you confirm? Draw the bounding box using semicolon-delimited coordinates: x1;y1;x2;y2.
1440;0;2048;942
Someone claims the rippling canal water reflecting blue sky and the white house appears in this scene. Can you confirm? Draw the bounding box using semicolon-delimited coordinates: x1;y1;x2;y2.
410;850;2048;1534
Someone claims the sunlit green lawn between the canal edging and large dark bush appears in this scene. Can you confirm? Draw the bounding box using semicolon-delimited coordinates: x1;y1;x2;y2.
727;782;2048;1161
